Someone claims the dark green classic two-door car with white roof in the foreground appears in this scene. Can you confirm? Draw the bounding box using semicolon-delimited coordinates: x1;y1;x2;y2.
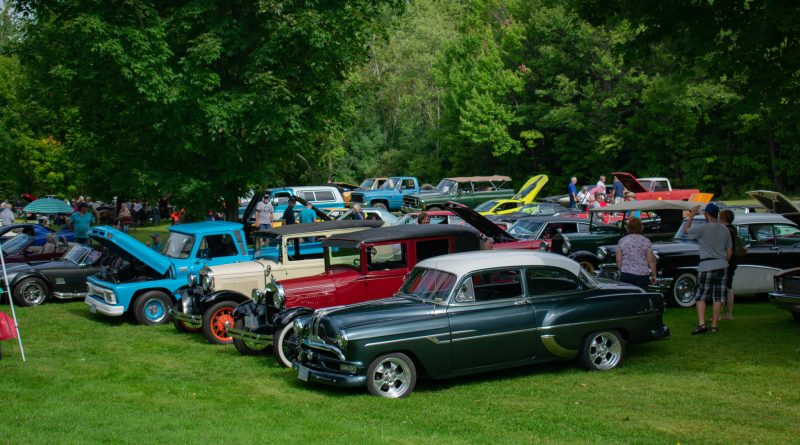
293;251;669;398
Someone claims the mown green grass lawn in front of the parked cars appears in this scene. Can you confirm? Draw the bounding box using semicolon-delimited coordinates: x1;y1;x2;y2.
0;299;800;444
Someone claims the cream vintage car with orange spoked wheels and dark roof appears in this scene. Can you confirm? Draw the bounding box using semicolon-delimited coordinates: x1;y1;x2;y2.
170;221;383;344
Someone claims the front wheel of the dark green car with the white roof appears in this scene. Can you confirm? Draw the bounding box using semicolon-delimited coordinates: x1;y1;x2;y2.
367;352;417;399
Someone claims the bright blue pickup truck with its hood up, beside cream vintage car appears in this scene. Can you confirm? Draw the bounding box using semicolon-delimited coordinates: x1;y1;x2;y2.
84;221;251;325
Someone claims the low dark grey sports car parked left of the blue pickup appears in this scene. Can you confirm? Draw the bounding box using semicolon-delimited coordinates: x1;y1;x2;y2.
0;245;104;306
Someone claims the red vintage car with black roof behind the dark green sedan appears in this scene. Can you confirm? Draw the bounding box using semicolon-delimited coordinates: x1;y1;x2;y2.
227;224;481;366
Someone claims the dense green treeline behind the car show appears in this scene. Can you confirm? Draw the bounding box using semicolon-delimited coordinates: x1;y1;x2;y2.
0;0;800;215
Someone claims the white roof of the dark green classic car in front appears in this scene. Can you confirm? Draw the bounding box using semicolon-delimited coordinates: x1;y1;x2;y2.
417;250;581;277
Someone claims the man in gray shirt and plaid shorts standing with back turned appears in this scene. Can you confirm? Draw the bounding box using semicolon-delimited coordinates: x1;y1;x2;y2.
683;202;733;335
